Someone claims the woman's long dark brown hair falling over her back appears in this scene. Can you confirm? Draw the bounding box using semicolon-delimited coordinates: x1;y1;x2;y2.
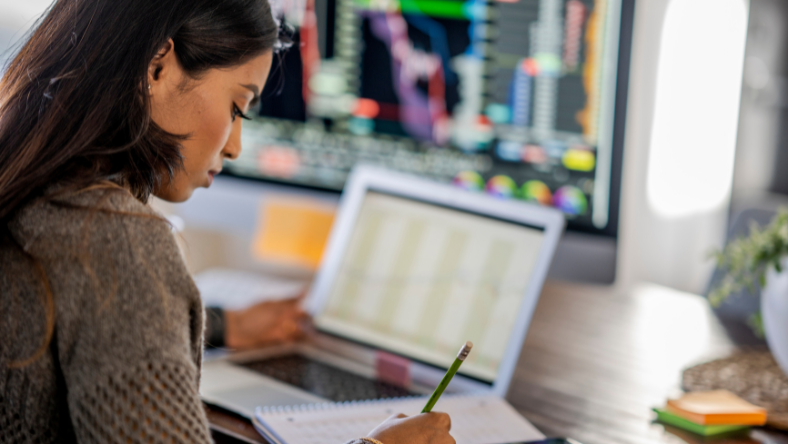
0;0;279;365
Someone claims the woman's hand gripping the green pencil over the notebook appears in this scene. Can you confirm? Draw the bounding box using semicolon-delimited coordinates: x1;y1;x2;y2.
368;412;455;444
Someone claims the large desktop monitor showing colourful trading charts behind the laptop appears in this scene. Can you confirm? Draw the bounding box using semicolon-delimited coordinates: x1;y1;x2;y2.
225;0;634;282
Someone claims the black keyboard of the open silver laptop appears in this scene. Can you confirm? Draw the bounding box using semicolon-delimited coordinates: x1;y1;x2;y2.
240;355;419;402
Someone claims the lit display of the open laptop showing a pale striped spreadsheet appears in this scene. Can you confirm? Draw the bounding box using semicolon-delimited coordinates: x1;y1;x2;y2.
315;190;544;383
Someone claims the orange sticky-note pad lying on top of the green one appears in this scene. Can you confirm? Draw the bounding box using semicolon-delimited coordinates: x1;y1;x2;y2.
666;390;766;426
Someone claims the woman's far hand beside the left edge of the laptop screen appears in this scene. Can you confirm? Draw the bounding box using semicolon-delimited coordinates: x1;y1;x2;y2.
224;299;307;349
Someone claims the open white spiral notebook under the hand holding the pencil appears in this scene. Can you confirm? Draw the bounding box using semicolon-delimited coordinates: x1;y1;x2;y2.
252;396;544;444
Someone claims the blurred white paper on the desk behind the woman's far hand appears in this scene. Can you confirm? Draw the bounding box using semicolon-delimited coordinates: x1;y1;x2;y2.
194;268;306;310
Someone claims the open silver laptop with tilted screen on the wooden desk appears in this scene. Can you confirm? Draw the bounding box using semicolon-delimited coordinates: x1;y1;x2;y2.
200;166;565;417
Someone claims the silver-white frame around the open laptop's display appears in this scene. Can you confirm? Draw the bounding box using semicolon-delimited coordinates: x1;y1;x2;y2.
305;165;565;396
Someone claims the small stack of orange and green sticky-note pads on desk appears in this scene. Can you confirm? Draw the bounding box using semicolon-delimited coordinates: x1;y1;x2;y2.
654;390;766;436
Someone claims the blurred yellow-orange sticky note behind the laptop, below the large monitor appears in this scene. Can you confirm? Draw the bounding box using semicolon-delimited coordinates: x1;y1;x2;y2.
252;199;335;269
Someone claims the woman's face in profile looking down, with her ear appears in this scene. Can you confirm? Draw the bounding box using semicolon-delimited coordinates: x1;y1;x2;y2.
147;41;273;202
